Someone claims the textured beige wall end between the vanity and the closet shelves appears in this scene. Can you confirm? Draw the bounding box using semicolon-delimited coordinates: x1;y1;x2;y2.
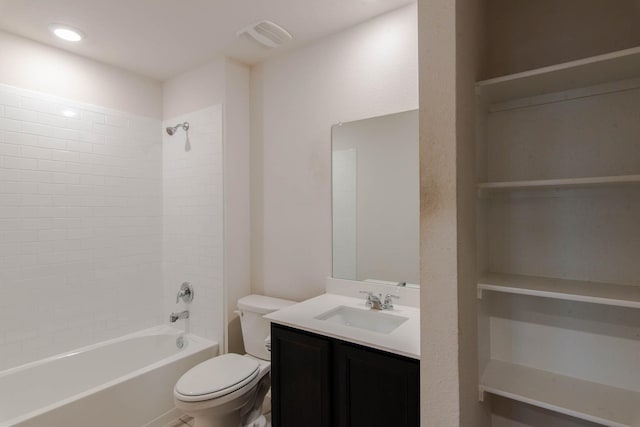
419;0;489;427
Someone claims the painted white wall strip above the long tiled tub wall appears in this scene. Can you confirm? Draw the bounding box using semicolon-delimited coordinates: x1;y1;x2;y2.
0;31;162;118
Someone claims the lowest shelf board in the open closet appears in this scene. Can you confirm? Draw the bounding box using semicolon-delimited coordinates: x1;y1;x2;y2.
480;360;640;427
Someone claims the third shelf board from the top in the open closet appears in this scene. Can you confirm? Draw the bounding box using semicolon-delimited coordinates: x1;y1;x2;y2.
478;273;640;308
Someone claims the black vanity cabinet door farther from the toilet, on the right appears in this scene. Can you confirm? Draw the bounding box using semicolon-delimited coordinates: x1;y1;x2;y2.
333;342;420;427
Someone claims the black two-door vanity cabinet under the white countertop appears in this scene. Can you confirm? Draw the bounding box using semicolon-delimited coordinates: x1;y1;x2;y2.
271;324;420;427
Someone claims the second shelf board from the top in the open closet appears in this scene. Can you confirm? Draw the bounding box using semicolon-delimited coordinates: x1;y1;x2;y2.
478;175;640;191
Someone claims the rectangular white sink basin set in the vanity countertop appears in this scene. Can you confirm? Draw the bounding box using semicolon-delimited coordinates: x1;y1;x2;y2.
315;305;409;334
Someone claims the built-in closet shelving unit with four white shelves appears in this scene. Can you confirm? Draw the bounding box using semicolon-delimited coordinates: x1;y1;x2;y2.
476;47;640;427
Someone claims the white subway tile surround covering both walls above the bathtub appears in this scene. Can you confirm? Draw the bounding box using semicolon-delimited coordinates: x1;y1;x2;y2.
0;85;235;370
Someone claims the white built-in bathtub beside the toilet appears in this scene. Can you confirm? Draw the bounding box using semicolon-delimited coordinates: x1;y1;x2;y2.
0;326;218;427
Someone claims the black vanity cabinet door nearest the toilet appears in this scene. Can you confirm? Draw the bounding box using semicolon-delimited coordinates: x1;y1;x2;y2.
271;325;332;427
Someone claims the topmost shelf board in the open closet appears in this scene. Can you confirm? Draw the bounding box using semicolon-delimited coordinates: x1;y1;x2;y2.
476;47;640;103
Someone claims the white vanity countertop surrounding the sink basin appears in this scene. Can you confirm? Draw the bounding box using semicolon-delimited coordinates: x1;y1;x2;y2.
265;293;420;359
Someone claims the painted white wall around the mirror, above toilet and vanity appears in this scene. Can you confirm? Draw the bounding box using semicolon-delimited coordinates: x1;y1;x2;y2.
251;5;418;300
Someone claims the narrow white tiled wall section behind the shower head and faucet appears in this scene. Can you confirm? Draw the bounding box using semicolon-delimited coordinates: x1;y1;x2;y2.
162;105;225;346
